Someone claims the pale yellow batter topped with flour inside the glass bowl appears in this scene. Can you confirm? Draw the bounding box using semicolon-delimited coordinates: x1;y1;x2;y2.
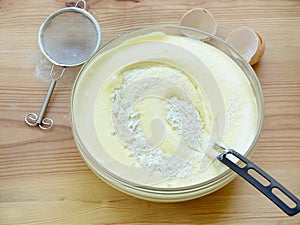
75;33;258;187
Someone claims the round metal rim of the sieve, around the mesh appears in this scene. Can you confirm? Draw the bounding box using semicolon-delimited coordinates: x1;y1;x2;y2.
38;7;101;67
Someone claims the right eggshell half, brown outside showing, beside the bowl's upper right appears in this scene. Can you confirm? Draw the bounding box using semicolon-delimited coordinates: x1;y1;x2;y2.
226;27;265;65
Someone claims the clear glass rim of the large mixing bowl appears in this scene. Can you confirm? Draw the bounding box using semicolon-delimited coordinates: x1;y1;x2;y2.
70;24;264;194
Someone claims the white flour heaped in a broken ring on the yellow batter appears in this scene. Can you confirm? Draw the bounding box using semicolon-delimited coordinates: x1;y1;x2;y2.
111;69;203;178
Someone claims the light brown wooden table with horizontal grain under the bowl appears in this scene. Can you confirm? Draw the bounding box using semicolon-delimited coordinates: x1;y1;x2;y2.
0;0;300;225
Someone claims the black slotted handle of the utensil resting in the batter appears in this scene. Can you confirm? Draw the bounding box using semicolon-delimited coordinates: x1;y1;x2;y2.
217;149;300;216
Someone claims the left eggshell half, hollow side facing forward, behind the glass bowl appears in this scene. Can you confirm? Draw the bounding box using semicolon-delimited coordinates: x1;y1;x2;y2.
180;8;217;40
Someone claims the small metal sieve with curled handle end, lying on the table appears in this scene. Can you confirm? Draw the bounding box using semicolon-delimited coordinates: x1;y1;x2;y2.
25;0;101;130
